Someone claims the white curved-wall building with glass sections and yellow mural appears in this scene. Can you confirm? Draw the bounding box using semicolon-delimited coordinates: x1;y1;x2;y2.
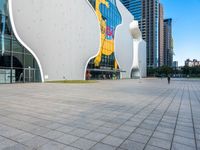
0;0;146;83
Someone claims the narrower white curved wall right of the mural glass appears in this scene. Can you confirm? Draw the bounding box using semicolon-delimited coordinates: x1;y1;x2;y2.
115;0;133;78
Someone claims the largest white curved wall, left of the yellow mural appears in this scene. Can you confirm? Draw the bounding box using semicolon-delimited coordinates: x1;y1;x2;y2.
9;0;100;80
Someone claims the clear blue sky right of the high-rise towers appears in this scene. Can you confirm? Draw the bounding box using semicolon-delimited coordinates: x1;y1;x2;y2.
160;0;200;66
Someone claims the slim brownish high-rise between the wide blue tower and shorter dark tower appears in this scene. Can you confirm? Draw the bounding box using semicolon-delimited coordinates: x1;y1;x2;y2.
158;4;164;67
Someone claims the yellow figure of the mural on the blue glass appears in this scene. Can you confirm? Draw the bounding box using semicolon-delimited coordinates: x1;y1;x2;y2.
94;0;117;68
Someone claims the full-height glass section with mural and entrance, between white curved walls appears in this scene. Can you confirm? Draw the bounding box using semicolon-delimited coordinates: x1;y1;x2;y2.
86;0;122;79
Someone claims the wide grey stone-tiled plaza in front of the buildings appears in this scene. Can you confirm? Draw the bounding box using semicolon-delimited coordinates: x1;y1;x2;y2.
0;79;200;150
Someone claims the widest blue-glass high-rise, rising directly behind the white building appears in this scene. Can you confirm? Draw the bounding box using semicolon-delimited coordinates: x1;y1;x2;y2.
121;0;159;67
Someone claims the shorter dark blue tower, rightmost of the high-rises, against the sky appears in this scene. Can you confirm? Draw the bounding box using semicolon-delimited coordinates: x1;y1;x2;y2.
164;18;173;67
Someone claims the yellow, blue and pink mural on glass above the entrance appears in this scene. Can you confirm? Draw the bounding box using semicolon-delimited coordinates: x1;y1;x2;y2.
89;0;122;69
